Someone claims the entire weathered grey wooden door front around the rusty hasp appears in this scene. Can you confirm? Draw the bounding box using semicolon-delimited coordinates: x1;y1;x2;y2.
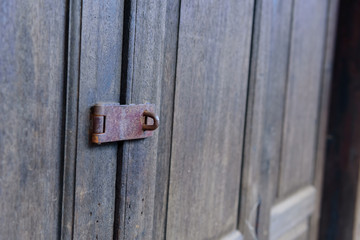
0;0;337;240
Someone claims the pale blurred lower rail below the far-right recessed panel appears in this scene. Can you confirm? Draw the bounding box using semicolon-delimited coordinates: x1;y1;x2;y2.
269;186;316;240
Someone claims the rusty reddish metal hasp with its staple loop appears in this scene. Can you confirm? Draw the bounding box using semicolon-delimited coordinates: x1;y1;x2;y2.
91;103;159;144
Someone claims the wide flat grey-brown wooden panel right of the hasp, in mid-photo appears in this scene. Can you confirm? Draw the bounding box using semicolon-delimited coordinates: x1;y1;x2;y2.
166;1;253;239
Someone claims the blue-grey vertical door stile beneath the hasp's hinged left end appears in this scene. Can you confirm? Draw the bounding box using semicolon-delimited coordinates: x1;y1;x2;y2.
67;0;124;239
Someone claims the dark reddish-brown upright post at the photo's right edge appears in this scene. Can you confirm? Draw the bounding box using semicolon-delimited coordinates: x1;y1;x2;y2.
319;0;360;239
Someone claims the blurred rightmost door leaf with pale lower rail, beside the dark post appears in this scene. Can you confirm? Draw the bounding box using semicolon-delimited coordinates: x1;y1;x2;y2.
240;0;337;239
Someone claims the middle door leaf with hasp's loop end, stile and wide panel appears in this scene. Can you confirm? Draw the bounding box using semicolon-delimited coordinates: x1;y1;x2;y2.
111;1;254;239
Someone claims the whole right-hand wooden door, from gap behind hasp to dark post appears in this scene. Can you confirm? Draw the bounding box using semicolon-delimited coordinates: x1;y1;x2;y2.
115;0;337;239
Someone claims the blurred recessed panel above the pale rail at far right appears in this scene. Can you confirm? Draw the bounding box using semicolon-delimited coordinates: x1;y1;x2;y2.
278;0;327;198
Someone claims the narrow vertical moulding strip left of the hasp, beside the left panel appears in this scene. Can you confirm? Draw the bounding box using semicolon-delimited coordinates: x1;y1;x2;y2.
61;0;81;239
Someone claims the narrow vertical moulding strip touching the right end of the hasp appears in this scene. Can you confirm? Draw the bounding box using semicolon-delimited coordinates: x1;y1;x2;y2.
153;0;180;240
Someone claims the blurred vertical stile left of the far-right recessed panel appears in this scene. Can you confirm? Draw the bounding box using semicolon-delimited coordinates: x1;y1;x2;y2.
240;0;292;239
